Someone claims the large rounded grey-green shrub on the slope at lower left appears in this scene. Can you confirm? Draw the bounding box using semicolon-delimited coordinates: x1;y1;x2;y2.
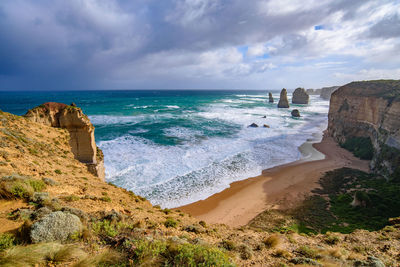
30;211;83;243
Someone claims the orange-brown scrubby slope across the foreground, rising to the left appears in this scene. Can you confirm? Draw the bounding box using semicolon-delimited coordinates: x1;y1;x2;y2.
0;105;400;266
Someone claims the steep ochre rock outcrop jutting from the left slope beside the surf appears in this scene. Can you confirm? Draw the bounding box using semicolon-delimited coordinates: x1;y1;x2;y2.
24;102;105;179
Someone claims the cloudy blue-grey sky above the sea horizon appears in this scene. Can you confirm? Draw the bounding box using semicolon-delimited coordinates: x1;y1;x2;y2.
0;0;400;91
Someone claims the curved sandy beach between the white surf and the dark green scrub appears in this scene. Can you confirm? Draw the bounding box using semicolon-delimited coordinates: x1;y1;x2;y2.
177;134;368;227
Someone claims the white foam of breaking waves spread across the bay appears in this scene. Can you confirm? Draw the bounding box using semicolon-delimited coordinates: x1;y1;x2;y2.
99;95;328;207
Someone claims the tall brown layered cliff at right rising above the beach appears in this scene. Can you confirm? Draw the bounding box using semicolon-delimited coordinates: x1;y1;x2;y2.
328;80;400;174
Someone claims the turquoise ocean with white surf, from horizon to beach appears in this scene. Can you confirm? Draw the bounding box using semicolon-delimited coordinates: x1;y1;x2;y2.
0;90;329;208
